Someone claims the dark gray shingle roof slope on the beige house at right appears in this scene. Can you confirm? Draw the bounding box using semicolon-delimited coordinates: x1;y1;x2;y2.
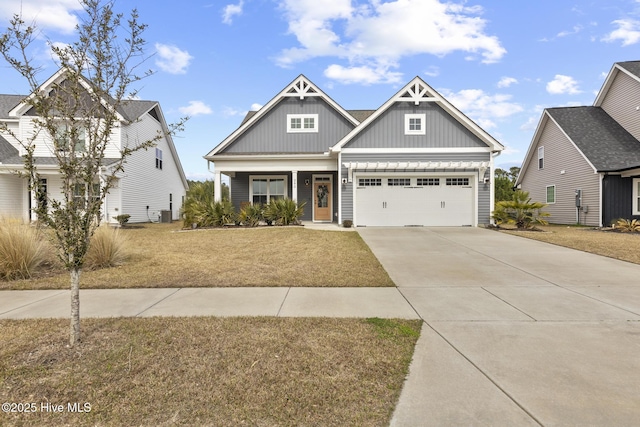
546;107;640;172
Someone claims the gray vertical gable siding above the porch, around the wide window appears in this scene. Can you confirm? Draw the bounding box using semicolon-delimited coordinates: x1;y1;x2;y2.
219;97;354;154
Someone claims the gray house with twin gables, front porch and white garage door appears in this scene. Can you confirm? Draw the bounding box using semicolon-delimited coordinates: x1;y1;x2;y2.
205;75;504;226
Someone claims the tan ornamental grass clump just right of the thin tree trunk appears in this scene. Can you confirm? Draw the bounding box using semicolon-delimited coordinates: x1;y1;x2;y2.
85;225;127;269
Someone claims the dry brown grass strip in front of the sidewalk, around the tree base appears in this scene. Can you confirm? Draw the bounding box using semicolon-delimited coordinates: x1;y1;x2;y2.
0;316;421;426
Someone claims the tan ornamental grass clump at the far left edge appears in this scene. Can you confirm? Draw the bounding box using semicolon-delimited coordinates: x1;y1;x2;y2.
0;219;45;280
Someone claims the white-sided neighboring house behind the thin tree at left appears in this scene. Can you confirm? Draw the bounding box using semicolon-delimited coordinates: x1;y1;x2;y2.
0;70;188;223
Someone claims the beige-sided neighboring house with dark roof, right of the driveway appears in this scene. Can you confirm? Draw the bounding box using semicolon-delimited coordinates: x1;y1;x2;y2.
516;61;640;226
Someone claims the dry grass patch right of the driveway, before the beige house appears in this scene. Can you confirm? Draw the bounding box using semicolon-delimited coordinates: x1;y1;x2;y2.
503;225;640;264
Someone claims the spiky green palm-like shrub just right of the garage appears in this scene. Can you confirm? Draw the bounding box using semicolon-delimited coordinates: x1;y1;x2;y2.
491;190;550;229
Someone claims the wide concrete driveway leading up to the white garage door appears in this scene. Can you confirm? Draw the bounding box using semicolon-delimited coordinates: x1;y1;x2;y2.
358;228;640;426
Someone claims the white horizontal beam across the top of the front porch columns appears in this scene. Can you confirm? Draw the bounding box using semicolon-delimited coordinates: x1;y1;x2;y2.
213;158;338;173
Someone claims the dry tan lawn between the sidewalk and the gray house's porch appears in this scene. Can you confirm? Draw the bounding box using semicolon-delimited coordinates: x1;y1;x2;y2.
0;224;393;289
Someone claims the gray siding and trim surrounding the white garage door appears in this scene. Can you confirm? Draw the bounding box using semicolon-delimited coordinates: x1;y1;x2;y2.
340;151;491;224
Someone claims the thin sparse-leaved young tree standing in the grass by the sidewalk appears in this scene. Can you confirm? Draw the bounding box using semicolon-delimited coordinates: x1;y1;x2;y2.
0;0;185;346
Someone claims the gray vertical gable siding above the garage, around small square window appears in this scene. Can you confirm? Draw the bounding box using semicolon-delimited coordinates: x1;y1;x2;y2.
344;102;487;149
